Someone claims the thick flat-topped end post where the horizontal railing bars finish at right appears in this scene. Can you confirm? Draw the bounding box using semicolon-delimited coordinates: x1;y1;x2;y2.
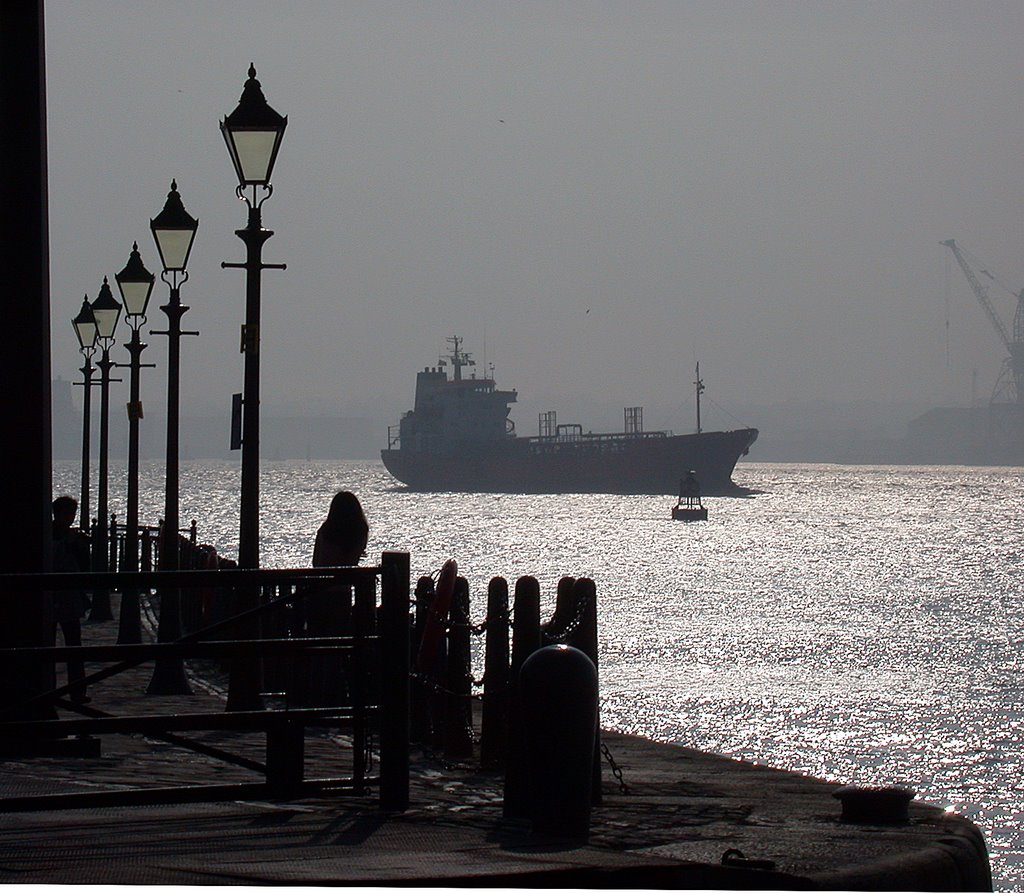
380;552;410;811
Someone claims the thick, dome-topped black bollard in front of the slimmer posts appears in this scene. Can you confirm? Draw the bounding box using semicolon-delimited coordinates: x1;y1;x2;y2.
519;645;597;840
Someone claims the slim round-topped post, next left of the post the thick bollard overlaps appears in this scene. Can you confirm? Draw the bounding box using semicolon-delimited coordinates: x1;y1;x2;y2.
480;577;509;769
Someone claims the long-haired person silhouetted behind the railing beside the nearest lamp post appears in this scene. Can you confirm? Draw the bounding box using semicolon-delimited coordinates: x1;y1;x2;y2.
305;490;370;707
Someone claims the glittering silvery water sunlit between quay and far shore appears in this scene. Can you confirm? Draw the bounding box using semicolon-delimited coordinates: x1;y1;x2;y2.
54;462;1024;890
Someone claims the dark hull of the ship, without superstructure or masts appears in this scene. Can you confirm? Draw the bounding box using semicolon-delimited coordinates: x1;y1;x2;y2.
381;428;758;495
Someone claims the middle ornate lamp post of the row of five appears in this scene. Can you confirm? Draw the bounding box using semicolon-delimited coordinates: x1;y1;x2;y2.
114;242;156;645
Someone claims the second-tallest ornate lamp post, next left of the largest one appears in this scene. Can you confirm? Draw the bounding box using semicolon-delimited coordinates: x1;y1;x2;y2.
146;180;199;694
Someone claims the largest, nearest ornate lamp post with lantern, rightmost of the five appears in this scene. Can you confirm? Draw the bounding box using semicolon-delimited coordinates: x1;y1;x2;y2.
220;63;288;710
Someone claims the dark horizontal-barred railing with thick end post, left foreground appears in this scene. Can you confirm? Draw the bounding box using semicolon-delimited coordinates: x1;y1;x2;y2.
0;552;410;811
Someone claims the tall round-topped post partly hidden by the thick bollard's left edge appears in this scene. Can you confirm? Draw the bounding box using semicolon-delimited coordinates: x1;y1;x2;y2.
503;577;541;818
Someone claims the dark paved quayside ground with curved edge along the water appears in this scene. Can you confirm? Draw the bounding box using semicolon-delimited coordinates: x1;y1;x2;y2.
0;624;991;890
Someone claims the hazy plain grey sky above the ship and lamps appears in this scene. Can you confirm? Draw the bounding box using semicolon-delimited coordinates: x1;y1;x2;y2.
46;0;1024;439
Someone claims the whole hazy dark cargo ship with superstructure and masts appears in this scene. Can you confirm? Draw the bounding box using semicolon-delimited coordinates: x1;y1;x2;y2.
381;336;758;495
